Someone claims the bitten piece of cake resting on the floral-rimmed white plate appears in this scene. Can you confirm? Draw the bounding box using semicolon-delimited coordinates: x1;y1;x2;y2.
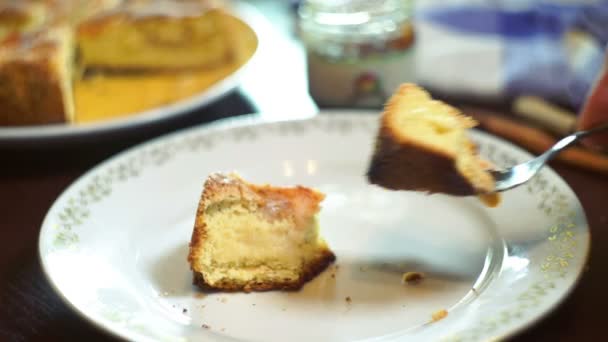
188;174;335;292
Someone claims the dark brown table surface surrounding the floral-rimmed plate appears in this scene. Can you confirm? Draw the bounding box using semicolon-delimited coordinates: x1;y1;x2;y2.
0;1;608;341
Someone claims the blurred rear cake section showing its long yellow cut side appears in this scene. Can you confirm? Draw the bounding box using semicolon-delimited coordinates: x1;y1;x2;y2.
78;0;233;70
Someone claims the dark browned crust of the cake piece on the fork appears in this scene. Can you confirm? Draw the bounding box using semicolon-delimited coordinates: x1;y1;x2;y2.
366;84;490;196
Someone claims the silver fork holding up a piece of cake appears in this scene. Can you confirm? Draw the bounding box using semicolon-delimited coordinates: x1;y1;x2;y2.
492;123;608;192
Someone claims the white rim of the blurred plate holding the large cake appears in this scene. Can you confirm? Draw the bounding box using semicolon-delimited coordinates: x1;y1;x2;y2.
0;2;268;146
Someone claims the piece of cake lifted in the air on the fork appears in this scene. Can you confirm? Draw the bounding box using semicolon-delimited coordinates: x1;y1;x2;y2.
367;84;495;198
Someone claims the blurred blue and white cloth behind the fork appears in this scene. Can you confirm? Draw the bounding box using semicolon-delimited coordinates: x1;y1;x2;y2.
415;0;608;109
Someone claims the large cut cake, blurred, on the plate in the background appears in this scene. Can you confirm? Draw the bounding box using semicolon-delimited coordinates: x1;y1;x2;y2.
0;0;234;126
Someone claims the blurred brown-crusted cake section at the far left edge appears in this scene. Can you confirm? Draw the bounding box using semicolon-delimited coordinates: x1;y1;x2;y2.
0;26;74;125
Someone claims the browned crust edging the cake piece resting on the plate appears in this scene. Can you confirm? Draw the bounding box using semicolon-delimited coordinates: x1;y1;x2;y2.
188;174;336;292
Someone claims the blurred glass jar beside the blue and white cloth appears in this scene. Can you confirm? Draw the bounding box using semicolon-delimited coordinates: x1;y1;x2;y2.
298;0;415;108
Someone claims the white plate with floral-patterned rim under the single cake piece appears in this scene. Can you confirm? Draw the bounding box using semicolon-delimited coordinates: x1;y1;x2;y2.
39;111;589;341
